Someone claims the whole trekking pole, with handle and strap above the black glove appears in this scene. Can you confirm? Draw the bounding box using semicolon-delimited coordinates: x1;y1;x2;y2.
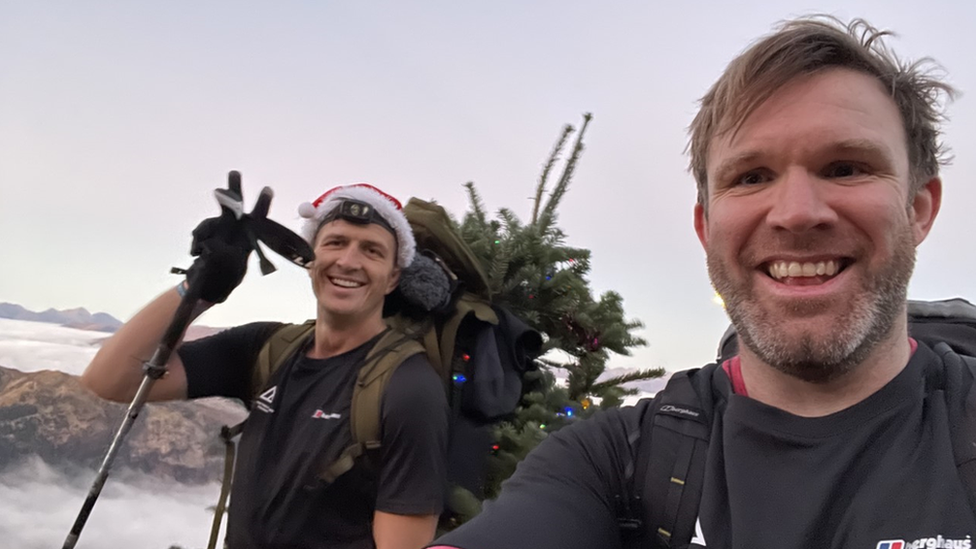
62;171;315;549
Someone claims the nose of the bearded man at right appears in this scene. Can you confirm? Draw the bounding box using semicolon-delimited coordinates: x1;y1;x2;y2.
766;167;837;233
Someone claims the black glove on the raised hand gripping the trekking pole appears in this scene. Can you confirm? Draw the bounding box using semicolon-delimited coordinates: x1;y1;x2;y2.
186;208;254;303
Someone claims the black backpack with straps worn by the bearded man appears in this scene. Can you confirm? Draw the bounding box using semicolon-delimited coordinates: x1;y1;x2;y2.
617;298;976;549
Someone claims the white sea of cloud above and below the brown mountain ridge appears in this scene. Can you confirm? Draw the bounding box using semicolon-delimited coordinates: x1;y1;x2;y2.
0;319;220;549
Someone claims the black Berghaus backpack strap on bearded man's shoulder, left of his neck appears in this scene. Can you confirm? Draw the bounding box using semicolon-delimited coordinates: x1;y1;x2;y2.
633;364;717;548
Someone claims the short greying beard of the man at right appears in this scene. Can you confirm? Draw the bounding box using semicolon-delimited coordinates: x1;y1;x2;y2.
708;225;915;383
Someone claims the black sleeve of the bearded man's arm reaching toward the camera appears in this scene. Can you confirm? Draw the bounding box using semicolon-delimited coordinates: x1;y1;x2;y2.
433;400;643;549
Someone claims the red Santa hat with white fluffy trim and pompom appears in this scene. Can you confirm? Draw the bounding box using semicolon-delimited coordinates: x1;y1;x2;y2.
298;183;417;269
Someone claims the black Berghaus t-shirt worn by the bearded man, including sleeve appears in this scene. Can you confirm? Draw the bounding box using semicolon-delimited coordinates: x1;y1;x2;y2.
434;344;976;549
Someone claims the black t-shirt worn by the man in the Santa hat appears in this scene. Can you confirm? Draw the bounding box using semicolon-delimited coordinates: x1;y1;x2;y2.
179;323;448;549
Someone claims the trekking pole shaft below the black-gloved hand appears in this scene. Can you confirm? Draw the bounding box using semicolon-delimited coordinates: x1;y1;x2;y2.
62;287;199;549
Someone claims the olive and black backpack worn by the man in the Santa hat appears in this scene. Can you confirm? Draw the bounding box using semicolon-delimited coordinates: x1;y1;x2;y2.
209;198;542;548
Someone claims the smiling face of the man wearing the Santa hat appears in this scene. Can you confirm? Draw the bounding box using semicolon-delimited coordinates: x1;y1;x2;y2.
309;219;400;325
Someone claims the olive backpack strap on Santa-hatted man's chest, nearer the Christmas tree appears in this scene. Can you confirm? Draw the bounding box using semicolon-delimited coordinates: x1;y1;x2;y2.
318;330;424;483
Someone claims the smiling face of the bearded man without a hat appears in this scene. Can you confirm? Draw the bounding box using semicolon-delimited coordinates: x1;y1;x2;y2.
695;68;941;382
